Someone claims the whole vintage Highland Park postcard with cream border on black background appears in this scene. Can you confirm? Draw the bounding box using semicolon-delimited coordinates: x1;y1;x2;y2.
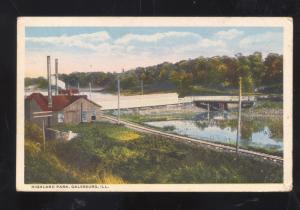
16;17;293;192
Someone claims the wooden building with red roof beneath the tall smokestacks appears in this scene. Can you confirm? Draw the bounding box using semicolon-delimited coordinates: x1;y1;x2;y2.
25;93;101;126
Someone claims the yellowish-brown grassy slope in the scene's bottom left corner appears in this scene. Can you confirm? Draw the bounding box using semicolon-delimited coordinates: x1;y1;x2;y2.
25;139;125;184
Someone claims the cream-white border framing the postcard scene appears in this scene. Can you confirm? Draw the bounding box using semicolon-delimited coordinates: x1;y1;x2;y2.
16;17;293;192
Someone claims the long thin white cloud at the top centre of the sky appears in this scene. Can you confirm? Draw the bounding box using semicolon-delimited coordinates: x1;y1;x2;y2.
115;31;200;44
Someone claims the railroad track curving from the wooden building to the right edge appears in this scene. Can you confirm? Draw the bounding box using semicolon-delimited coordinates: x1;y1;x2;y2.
102;115;283;163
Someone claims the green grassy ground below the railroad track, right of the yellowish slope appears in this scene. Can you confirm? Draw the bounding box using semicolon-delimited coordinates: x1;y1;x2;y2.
48;123;282;183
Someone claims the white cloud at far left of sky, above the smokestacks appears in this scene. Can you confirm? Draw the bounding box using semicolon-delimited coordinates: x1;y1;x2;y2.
26;31;110;50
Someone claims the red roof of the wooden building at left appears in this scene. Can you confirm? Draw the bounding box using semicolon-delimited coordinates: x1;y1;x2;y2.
26;93;101;111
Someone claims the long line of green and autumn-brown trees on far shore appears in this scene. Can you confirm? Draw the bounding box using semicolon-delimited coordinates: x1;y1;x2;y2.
24;52;283;95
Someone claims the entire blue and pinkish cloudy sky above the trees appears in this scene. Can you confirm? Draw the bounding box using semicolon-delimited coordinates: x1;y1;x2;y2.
25;27;283;77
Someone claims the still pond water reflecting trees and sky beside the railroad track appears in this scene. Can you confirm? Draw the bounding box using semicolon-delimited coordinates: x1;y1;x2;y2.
146;112;283;151
